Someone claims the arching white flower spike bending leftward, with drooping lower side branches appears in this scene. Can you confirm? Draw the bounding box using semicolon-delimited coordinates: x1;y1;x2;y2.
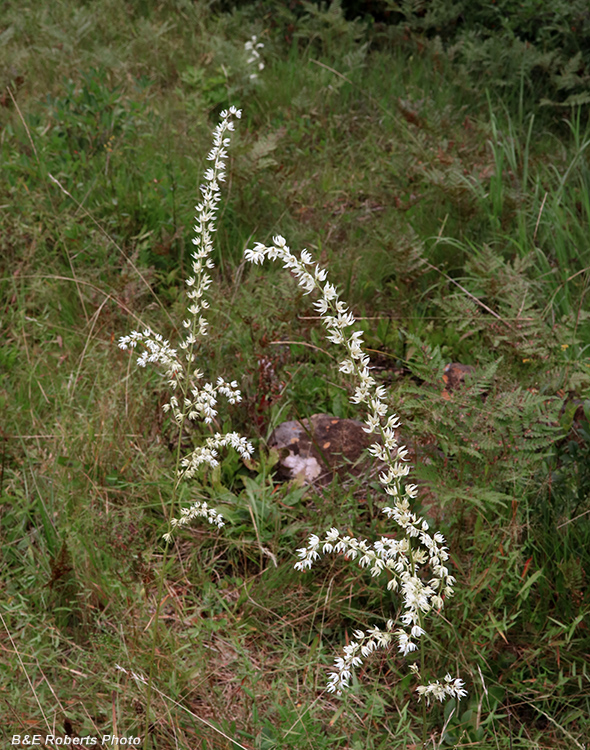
244;236;464;698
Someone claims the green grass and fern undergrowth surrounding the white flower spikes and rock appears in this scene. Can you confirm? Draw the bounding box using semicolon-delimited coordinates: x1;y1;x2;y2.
0;0;590;750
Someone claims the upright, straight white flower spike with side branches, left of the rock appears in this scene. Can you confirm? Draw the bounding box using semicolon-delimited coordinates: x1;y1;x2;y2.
119;107;254;536
